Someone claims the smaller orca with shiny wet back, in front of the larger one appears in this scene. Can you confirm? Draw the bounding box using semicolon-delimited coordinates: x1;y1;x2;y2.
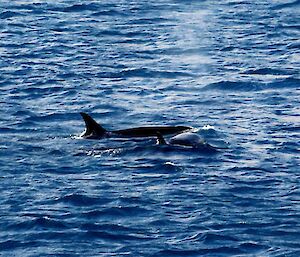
156;131;217;151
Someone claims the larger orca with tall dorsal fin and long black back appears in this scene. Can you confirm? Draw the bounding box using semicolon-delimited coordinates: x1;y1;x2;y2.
80;112;192;139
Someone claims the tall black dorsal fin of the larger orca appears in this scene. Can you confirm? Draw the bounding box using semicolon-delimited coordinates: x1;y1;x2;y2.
80;112;107;138
